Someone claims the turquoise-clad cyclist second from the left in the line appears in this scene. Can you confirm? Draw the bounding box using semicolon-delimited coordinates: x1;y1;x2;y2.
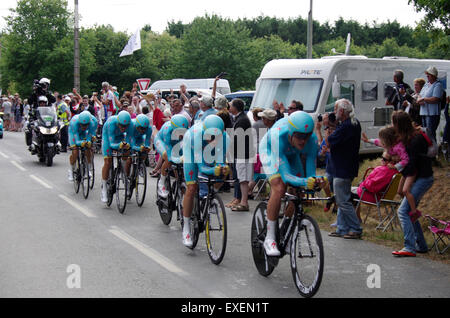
101;111;132;203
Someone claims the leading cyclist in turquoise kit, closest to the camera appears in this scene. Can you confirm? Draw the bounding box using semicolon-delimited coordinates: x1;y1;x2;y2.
259;111;324;256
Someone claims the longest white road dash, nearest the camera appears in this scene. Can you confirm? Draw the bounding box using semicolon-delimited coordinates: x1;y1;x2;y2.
109;226;187;276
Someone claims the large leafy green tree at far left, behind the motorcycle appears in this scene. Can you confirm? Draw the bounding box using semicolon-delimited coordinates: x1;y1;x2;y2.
1;0;70;95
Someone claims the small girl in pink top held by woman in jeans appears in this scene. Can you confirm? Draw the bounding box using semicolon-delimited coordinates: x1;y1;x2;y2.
362;126;420;220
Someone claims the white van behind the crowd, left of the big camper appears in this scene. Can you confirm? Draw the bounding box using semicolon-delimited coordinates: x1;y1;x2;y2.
149;78;231;95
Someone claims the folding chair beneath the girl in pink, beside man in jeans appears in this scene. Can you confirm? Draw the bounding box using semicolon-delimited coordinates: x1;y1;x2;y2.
354;173;402;232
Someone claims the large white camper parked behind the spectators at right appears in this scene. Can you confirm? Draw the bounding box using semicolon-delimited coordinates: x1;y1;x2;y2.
251;56;450;153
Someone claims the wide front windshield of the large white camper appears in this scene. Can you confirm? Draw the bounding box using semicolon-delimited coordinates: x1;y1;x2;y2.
252;79;323;112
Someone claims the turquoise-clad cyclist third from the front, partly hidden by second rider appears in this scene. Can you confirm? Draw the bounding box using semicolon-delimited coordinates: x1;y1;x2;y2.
155;115;189;199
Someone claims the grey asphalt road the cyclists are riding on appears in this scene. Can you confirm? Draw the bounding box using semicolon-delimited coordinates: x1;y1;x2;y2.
0;132;450;298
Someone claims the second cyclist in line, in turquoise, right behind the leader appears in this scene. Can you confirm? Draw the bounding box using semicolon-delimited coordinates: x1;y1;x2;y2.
183;115;230;248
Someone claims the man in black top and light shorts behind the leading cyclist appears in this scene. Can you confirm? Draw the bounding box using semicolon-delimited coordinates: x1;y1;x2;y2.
230;98;254;211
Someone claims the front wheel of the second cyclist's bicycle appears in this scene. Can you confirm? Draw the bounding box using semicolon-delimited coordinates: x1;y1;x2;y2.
205;195;227;265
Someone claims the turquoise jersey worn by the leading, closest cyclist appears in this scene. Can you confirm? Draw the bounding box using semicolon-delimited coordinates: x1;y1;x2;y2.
259;118;318;187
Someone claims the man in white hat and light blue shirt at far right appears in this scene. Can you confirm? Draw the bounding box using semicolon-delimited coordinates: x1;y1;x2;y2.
417;66;443;141
